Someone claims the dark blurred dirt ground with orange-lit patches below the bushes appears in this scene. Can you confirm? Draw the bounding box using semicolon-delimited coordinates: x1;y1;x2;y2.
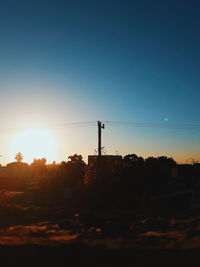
0;190;200;266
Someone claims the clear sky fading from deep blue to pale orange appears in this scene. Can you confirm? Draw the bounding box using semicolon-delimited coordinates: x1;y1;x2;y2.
0;0;200;164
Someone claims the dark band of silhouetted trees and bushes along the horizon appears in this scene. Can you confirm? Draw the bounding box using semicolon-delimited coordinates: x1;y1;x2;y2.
0;152;200;214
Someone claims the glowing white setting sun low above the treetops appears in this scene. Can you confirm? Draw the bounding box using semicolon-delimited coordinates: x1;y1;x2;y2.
10;128;57;163
